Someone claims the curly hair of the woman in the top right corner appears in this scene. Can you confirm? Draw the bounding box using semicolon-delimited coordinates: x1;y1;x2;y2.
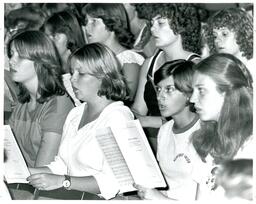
207;8;253;59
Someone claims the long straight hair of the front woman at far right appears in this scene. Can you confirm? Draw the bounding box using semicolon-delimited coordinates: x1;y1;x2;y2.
192;53;253;163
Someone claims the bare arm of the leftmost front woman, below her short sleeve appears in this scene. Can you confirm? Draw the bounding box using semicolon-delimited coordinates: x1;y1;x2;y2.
35;132;61;167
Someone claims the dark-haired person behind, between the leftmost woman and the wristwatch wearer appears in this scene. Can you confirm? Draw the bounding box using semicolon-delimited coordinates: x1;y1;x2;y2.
41;10;85;106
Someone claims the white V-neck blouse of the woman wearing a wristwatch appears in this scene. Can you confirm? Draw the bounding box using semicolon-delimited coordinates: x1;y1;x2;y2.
48;101;134;199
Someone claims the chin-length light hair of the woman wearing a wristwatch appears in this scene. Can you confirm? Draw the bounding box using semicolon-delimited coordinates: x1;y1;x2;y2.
68;43;128;101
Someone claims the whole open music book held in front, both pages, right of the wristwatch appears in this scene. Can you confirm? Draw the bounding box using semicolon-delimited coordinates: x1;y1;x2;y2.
96;120;166;193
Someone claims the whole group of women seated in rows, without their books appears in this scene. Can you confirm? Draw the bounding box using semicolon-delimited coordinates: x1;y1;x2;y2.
4;3;254;201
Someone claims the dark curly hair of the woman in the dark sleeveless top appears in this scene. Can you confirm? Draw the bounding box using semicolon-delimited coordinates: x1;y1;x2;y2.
143;3;201;54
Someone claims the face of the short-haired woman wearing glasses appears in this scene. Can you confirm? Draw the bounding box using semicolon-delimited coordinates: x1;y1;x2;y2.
156;76;187;117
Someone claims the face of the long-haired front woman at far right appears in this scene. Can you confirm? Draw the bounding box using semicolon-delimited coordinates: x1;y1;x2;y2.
190;72;225;121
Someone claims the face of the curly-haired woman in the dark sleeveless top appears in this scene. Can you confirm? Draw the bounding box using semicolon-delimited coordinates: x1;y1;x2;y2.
151;15;178;48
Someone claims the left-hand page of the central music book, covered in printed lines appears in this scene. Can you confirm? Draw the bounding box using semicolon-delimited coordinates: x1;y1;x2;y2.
96;128;136;193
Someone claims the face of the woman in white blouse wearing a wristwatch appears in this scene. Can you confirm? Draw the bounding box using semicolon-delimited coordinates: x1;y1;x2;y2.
71;59;101;102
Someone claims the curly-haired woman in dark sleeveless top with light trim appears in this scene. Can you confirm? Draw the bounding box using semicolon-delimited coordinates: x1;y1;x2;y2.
132;3;200;151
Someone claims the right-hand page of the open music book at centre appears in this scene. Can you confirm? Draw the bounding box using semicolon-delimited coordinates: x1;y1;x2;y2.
111;120;166;188
